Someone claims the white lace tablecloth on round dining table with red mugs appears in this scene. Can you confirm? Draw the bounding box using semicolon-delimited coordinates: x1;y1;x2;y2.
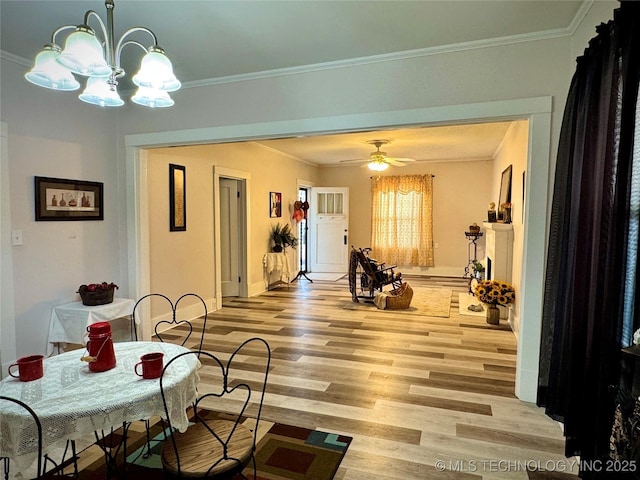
0;342;200;473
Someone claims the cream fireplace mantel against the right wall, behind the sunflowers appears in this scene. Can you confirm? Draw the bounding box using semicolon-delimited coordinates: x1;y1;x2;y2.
482;223;513;283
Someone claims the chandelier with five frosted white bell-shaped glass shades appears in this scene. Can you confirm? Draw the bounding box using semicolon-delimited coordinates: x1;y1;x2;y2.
25;0;181;108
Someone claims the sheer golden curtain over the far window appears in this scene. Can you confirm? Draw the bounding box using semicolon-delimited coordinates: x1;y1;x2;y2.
371;175;433;267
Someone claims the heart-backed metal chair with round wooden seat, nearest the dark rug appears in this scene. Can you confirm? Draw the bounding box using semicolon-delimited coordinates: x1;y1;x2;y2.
160;338;271;479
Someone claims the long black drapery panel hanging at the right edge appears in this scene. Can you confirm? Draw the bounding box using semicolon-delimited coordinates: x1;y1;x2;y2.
538;1;640;472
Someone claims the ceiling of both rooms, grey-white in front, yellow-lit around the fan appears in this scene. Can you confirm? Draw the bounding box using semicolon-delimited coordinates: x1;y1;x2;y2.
0;0;593;165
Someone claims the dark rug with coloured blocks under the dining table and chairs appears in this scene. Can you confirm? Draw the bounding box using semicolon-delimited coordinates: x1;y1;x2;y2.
65;412;352;480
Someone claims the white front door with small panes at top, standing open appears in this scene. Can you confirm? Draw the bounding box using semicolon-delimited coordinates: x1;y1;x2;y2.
309;187;349;273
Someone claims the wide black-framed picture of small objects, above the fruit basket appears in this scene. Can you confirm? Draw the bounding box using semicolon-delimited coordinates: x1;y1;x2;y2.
34;177;104;221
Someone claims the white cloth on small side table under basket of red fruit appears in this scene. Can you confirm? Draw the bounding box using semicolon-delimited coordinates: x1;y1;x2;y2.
47;297;139;356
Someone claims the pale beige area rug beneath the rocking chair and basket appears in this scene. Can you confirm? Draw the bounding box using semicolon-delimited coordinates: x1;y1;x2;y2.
343;285;452;317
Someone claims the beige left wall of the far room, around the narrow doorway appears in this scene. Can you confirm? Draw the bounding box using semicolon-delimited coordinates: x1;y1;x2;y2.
147;142;317;318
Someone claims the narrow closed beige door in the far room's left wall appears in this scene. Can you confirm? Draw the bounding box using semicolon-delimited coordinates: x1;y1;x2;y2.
220;178;240;297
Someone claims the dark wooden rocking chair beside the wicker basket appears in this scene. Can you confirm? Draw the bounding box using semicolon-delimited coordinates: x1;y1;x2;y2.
349;245;402;303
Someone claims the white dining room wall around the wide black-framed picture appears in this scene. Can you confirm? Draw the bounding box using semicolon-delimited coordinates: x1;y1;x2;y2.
0;60;119;364
